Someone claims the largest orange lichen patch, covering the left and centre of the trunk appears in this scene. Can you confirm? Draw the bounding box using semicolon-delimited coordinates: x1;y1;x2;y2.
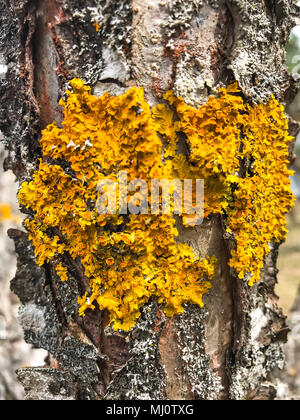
19;79;216;330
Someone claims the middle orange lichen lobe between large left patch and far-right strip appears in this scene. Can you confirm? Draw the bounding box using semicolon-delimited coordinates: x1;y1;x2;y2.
157;85;245;217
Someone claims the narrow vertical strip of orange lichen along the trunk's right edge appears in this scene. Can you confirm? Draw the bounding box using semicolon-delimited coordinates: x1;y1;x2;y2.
228;98;295;285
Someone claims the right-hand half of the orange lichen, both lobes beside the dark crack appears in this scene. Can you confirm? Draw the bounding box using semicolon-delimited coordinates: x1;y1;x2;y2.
157;83;295;285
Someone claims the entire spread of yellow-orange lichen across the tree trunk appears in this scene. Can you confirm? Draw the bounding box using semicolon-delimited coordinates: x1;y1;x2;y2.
19;79;293;330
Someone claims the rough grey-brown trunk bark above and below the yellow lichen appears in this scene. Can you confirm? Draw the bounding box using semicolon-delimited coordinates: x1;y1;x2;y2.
0;0;299;399
